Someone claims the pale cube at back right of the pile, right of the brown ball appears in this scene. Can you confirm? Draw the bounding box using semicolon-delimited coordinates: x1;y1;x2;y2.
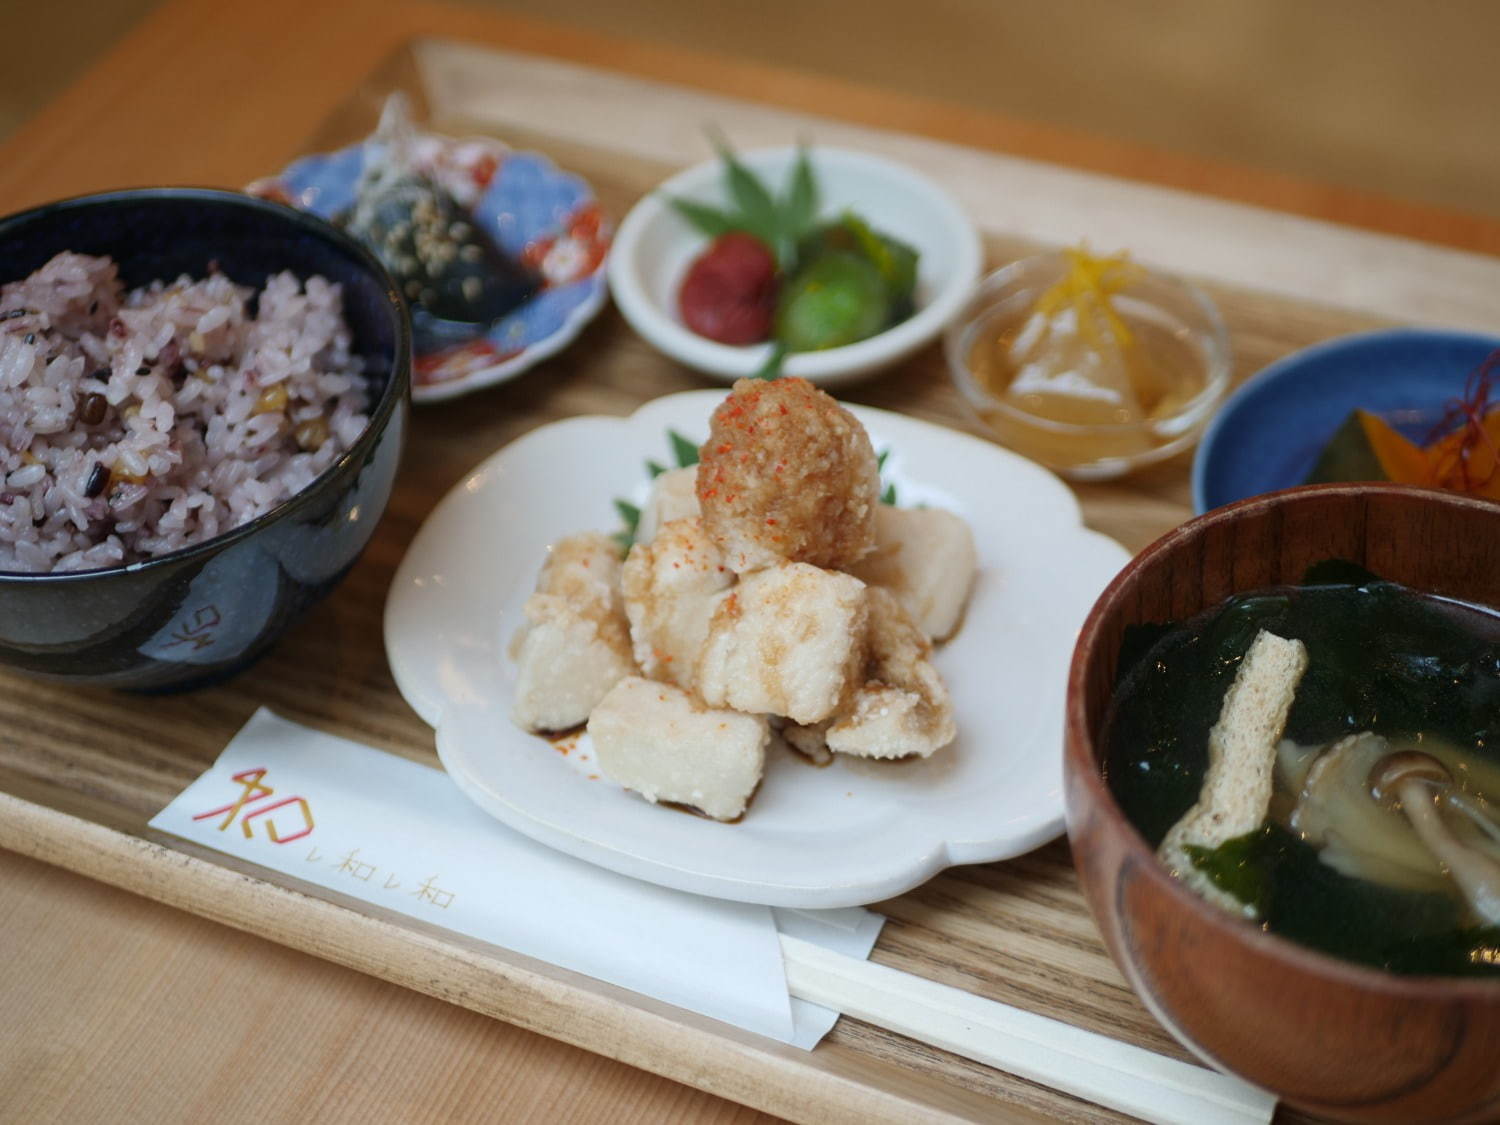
849;504;980;641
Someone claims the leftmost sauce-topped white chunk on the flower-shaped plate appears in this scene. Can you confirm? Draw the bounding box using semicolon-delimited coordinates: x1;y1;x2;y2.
510;533;636;731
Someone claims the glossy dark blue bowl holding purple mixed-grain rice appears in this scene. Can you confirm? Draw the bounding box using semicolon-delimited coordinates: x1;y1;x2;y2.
0;188;411;690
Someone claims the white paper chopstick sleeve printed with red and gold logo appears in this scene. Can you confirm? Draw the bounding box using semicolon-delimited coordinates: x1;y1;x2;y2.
150;708;885;1050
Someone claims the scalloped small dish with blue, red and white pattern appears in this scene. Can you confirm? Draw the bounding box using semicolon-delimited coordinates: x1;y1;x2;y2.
248;132;612;402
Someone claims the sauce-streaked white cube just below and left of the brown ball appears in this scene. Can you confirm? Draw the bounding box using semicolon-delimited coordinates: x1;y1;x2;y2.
621;525;735;689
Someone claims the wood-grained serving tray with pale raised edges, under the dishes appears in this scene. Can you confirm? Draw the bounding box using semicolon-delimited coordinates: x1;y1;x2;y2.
0;35;1500;1122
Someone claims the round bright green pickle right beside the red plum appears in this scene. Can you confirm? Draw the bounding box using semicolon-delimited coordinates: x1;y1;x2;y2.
776;251;891;351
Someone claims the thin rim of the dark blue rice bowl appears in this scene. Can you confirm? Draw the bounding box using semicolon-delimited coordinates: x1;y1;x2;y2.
0;188;411;585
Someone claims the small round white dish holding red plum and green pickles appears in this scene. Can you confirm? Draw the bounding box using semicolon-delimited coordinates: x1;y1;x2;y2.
608;146;984;387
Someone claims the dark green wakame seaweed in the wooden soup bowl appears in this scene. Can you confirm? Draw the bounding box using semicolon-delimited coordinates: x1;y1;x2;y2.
1104;563;1500;977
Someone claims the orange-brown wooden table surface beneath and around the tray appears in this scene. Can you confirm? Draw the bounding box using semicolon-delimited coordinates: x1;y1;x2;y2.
0;0;1500;1122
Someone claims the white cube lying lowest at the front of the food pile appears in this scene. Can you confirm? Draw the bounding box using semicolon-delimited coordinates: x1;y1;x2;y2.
588;677;771;821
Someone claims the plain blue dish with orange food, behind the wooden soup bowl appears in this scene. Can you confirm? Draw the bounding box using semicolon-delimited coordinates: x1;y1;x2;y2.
1193;329;1500;515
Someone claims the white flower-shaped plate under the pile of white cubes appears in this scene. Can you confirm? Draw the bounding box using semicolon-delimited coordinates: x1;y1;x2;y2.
386;392;1130;908
